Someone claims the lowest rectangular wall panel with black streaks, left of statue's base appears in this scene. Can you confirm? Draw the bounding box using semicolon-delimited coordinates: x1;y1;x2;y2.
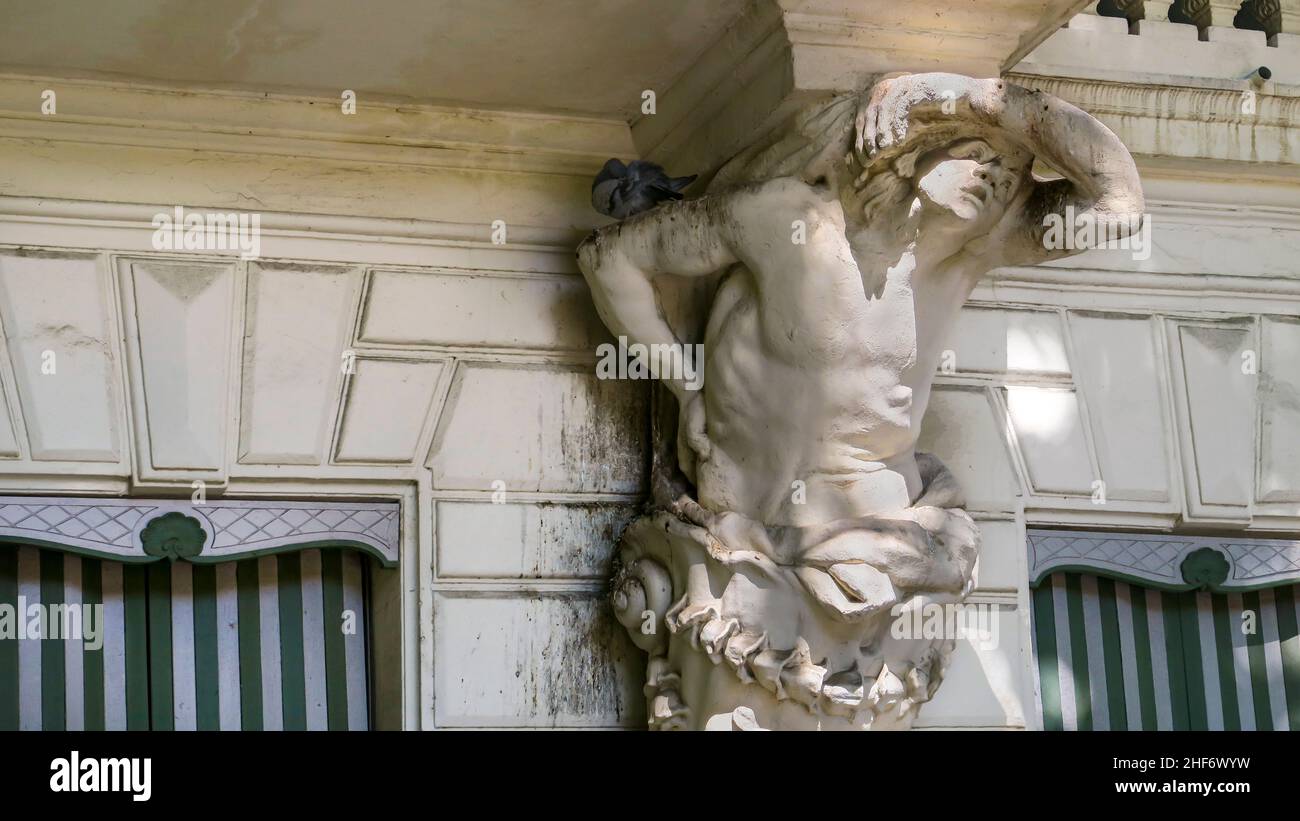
433;592;645;727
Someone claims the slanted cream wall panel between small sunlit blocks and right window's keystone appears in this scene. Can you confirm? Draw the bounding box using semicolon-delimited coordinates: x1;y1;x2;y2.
1069;312;1171;501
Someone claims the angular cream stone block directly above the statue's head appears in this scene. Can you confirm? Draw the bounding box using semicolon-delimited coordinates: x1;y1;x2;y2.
632;0;1089;177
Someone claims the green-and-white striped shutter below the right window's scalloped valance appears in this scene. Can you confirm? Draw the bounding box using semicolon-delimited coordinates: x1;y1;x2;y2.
1032;572;1300;730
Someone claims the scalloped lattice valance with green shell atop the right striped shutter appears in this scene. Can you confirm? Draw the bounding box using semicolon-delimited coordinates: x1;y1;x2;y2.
1028;530;1300;592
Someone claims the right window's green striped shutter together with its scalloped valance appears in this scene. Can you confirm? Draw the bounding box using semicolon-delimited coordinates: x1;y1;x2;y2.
1028;530;1300;730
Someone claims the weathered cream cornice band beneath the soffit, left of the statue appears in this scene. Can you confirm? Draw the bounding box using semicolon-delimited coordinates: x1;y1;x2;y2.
0;74;634;177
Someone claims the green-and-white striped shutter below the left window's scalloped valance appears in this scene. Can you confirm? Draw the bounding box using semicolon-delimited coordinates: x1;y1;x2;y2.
0;544;368;730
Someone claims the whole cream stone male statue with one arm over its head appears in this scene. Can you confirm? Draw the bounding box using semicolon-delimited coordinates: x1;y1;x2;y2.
579;74;1143;729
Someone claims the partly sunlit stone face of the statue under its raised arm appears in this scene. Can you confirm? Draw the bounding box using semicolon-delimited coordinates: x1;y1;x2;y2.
915;139;1024;230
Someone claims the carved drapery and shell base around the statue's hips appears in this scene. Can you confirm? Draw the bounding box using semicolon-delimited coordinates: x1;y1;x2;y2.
612;453;979;729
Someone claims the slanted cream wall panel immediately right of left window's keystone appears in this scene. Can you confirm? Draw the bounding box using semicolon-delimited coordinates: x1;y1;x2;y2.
239;264;360;465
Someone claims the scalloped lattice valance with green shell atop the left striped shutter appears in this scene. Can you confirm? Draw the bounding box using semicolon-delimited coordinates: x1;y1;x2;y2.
0;496;400;568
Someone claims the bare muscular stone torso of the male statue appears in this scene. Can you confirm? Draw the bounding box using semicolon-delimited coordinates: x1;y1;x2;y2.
697;185;972;525
